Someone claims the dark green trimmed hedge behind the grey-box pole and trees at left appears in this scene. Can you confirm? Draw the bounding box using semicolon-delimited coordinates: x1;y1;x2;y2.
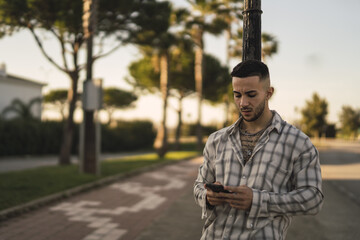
0;119;155;156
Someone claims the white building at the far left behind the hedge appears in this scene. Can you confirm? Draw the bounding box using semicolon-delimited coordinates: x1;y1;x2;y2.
0;64;46;119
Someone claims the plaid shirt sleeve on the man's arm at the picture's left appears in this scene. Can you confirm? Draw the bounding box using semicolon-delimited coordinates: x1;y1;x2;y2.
194;135;215;218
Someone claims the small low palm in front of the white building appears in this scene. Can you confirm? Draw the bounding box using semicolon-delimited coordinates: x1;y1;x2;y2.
2;97;41;121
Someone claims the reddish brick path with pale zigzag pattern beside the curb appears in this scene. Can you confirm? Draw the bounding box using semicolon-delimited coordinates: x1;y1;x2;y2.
0;158;202;240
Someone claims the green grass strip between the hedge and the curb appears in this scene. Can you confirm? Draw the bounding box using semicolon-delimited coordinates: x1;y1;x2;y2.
0;151;199;211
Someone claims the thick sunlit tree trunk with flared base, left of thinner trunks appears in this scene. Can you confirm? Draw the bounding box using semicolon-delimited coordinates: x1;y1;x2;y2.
154;53;169;157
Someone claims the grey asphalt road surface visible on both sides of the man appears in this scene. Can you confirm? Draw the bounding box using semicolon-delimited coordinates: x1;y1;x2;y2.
136;142;360;240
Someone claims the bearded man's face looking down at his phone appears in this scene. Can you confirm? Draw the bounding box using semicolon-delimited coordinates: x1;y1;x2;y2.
232;76;270;122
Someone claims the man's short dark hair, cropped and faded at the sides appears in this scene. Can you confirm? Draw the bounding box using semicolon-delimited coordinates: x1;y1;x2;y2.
230;60;270;80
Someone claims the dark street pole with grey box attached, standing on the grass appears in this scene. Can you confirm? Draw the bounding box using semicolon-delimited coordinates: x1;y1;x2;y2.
80;0;101;175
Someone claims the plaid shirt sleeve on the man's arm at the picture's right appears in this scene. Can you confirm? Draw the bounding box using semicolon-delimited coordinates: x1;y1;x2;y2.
247;139;324;228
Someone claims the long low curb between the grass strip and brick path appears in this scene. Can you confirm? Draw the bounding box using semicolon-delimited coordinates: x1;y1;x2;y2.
0;155;201;222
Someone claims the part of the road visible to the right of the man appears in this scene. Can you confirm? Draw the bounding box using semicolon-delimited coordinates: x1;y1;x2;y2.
287;144;360;240
